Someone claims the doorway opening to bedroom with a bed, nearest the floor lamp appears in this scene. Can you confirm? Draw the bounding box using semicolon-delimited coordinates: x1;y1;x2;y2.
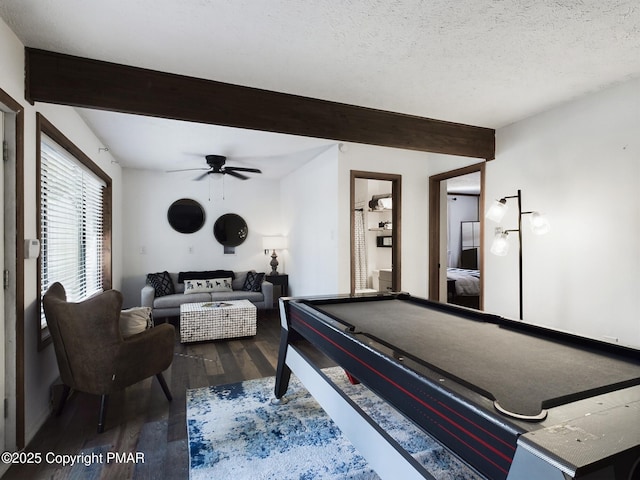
429;162;485;310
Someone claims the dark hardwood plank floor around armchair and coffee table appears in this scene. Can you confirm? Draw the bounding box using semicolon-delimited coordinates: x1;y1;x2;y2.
2;311;330;480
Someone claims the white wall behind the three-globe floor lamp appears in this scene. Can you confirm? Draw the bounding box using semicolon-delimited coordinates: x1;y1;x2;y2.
485;79;640;347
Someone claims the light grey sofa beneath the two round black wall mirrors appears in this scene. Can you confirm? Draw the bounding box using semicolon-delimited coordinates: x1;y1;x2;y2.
140;271;273;320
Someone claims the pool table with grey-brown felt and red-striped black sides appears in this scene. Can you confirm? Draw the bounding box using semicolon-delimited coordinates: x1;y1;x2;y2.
275;294;640;480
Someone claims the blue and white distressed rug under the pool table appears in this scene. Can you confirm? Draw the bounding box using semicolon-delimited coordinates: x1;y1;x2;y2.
187;368;480;480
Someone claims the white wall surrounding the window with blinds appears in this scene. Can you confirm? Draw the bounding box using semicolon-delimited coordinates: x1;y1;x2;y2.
0;16;122;442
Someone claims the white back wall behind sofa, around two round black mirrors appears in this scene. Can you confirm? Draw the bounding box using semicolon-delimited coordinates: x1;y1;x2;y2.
122;169;285;306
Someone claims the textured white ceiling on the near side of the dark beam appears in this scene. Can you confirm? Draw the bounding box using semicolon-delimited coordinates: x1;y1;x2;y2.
0;0;640;172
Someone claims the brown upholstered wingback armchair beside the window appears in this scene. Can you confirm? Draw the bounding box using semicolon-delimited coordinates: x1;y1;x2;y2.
42;283;175;433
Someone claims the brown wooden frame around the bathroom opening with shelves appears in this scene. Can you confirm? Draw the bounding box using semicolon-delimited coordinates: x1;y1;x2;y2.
349;170;402;295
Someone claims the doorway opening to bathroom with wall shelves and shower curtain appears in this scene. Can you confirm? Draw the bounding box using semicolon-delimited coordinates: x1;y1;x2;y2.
350;170;402;294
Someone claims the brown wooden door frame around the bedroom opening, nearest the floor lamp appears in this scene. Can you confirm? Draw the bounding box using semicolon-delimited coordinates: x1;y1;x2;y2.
428;162;486;304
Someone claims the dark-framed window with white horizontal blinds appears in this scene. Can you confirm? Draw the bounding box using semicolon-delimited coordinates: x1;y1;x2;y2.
38;116;111;345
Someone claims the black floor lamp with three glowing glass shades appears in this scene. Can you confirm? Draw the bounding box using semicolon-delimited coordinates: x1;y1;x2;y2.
486;190;551;320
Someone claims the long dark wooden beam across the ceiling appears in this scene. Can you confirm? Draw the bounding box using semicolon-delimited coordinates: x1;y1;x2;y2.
25;48;495;160
